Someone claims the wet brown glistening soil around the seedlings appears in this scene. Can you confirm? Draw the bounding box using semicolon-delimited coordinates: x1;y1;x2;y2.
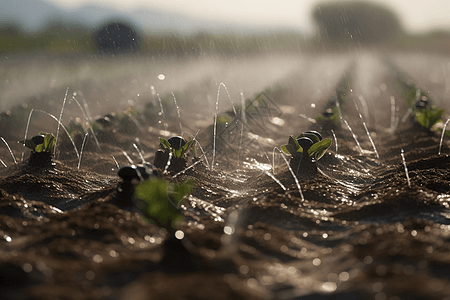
0;52;450;300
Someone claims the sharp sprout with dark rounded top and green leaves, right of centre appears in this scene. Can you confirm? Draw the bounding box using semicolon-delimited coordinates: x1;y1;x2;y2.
281;131;331;180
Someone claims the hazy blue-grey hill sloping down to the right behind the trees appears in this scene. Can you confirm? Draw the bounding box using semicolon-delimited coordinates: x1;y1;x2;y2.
0;0;292;33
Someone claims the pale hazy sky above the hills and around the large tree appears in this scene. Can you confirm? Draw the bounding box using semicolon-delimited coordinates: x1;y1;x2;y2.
45;0;450;32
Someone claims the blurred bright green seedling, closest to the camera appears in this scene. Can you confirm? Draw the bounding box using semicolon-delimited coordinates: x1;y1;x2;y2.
135;177;194;231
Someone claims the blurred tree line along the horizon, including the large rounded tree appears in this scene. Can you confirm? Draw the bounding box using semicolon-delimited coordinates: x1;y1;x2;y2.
0;1;450;56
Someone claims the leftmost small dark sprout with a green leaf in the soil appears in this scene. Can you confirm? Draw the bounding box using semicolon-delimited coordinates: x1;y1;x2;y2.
19;132;56;167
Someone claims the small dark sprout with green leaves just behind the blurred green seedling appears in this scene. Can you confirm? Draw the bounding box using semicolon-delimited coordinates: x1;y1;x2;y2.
153;136;196;173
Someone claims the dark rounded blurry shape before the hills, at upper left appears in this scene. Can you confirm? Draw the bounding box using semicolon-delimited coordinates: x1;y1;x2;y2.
94;22;139;53
